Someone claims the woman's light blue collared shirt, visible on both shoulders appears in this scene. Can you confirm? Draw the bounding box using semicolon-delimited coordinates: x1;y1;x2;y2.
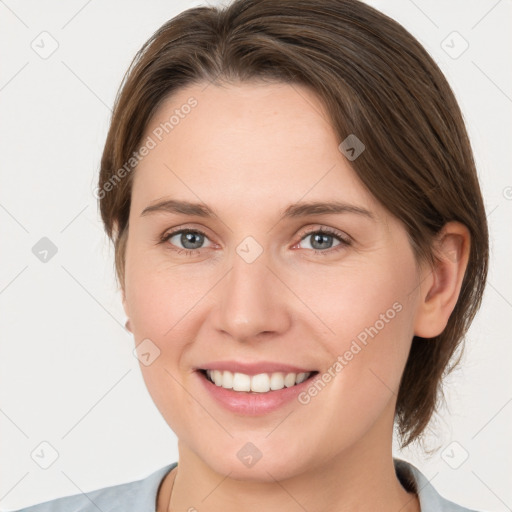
11;459;484;512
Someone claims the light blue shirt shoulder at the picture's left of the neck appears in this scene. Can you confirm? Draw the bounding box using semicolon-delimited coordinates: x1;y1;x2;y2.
10;462;177;512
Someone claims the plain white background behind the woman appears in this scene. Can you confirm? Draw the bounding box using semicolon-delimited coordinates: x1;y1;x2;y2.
0;0;512;512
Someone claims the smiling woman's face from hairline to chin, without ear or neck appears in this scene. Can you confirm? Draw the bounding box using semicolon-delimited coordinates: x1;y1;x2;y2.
124;83;420;480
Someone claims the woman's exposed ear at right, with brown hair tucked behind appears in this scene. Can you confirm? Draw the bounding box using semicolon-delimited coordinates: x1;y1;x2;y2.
414;222;471;338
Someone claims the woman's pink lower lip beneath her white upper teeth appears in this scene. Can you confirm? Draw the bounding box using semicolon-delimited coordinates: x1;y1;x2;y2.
196;371;319;416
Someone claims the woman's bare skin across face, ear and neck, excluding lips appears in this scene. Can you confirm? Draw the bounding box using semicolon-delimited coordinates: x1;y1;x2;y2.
119;82;469;512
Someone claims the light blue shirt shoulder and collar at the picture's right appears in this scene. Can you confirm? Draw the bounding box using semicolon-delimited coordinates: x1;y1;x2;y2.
393;459;484;512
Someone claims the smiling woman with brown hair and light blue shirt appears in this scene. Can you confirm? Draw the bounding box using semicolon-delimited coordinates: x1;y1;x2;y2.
15;0;488;512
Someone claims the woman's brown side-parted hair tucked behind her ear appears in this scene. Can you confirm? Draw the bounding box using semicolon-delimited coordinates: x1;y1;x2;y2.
98;0;488;446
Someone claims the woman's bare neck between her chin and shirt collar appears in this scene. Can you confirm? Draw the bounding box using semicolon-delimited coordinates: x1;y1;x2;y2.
157;445;420;512
